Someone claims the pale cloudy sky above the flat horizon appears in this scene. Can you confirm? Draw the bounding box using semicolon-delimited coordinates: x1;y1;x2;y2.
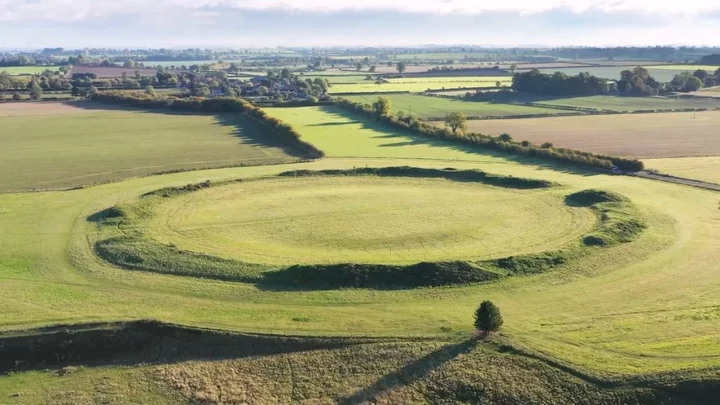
0;0;720;49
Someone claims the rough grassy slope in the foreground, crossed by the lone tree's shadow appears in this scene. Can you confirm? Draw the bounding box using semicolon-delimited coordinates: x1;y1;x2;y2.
0;341;676;405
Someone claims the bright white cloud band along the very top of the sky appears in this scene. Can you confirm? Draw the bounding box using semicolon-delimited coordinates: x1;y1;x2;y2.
0;0;720;21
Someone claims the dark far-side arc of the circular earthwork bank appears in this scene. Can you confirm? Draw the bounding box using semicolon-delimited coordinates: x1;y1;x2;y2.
278;166;554;189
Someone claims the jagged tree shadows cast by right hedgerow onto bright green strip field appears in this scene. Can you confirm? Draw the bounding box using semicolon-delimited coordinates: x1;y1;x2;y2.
323;107;603;176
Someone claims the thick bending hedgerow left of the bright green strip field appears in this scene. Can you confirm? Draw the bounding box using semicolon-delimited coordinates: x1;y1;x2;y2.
91;91;325;158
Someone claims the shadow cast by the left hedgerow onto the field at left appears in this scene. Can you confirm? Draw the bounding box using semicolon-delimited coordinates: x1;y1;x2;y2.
63;101;307;158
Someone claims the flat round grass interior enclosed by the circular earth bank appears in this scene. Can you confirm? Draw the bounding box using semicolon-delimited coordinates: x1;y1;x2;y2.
145;177;596;265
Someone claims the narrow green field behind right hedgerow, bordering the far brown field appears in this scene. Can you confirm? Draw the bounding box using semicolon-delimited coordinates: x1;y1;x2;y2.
343;94;573;119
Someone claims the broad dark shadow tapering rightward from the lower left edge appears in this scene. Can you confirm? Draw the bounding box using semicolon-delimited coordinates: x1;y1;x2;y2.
0;321;376;375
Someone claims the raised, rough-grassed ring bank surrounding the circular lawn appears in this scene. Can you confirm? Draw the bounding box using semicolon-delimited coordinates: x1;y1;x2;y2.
88;166;644;290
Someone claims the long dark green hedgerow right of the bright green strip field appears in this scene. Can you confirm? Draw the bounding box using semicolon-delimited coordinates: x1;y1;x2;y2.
337;98;644;172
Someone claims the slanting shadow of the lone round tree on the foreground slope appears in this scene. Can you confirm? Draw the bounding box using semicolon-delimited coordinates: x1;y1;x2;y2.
337;339;477;405
